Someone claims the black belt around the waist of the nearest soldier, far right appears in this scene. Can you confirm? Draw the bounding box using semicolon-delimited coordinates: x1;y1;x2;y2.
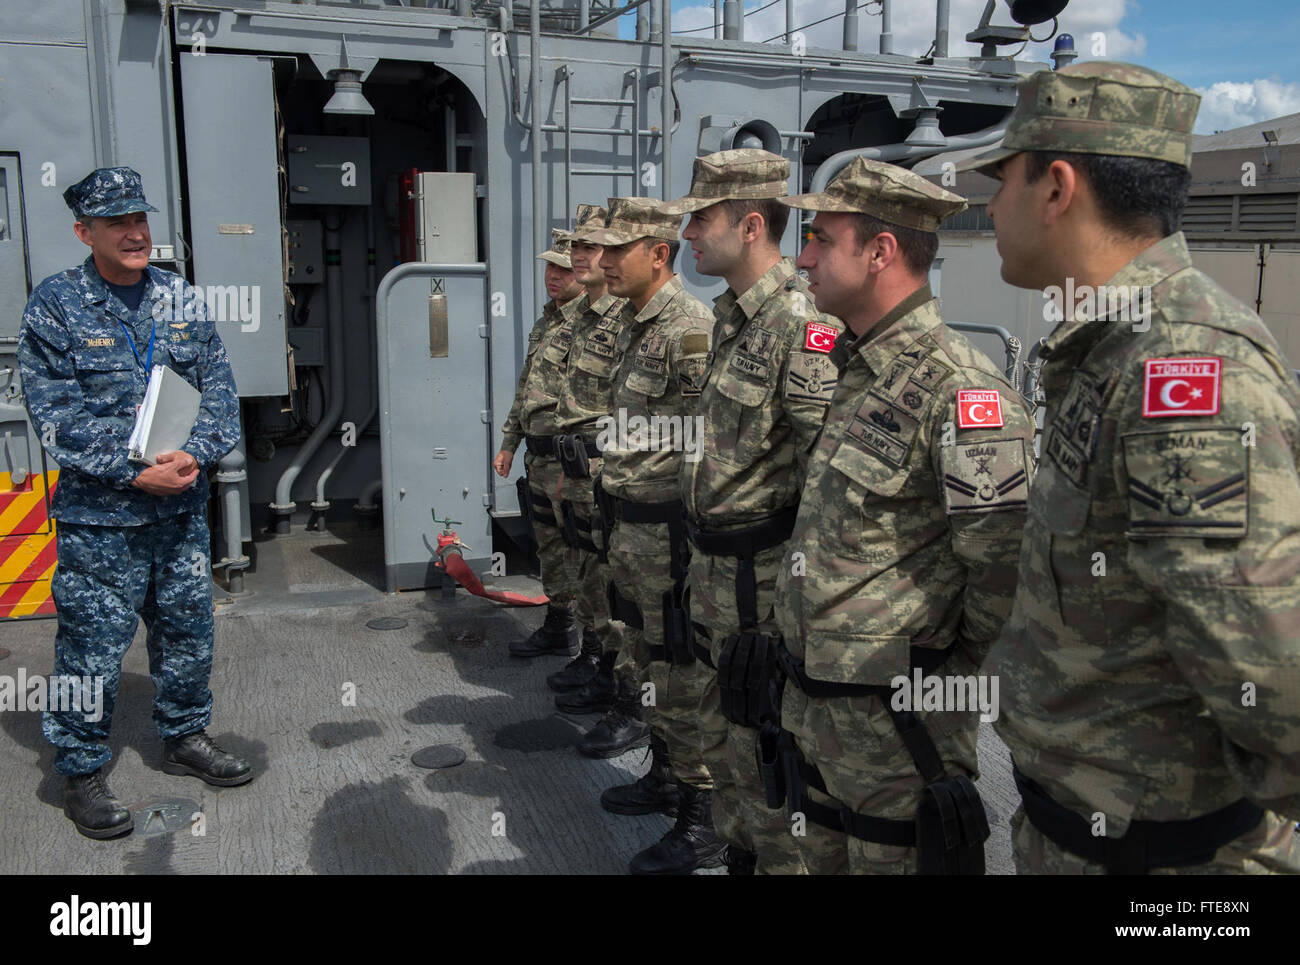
1011;767;1264;874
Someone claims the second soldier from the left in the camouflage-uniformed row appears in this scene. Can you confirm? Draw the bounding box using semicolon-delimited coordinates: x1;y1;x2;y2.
546;204;625;714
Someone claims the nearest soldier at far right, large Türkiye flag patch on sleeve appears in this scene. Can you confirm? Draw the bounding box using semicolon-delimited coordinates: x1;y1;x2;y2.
970;62;1300;874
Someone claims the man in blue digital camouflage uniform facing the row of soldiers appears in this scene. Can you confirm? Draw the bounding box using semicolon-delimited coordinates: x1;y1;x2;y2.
18;168;252;838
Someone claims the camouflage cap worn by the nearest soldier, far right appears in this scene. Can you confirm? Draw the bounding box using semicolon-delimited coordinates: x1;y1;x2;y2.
957;61;1201;178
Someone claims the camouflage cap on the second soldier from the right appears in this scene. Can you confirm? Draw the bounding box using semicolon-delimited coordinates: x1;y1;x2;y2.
780;157;966;231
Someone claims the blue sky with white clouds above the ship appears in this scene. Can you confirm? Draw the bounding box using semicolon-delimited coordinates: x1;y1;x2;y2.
619;0;1300;134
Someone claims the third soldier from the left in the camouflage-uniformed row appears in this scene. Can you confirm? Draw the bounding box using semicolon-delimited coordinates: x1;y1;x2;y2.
584;198;724;874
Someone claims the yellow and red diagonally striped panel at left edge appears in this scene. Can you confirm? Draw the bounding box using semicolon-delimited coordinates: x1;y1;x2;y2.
0;472;59;619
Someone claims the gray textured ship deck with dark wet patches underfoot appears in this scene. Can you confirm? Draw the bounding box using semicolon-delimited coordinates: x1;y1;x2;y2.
0;532;1017;874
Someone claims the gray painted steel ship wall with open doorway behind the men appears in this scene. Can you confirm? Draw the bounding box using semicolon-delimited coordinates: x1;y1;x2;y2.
0;0;1040;590
